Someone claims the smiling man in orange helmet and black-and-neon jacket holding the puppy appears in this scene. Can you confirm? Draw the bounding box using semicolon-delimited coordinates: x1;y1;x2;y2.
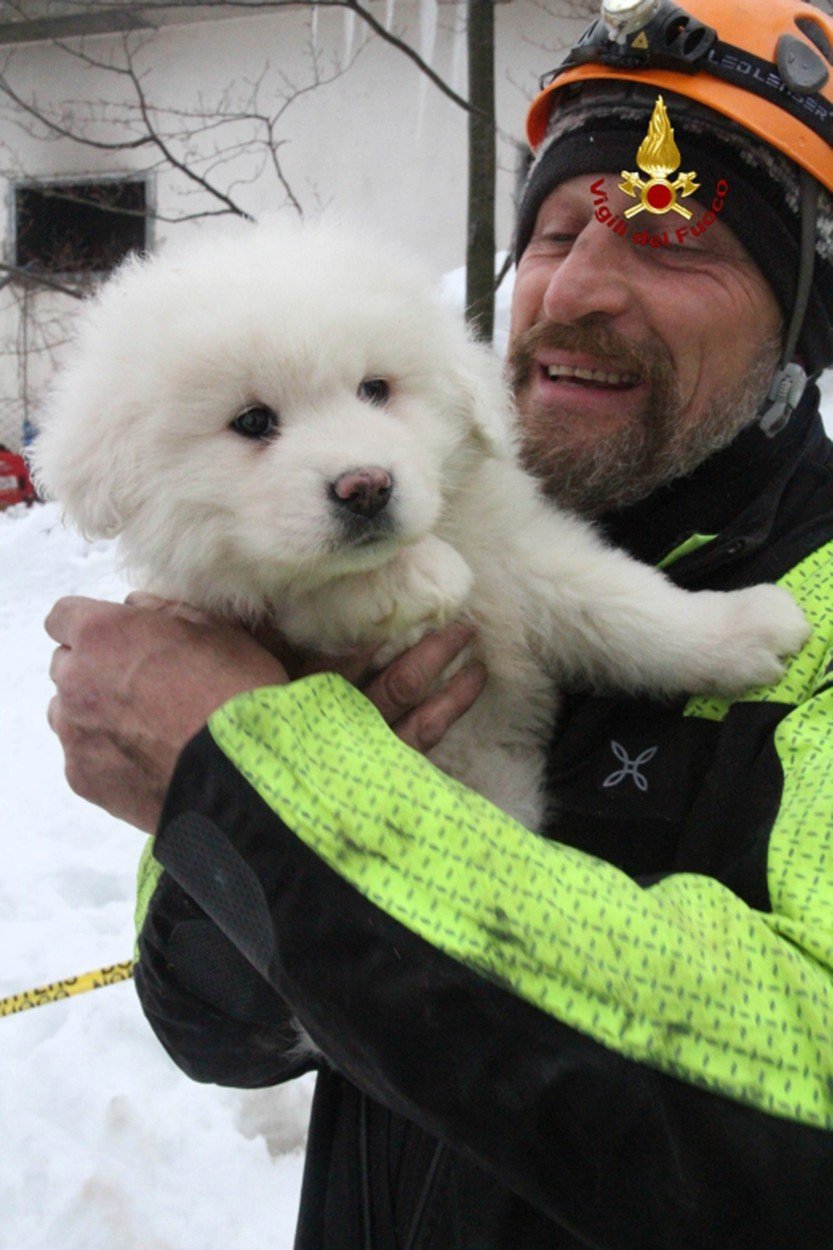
49;0;833;1250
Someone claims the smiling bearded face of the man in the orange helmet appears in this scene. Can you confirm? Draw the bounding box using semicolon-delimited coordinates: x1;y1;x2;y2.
509;175;782;515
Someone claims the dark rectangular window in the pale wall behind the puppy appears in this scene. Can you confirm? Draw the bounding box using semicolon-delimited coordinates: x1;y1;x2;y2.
15;180;148;274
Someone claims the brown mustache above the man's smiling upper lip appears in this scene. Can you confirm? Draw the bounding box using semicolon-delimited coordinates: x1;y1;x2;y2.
507;315;674;394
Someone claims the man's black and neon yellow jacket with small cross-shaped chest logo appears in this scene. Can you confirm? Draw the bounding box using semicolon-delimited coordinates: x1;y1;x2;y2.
136;392;833;1250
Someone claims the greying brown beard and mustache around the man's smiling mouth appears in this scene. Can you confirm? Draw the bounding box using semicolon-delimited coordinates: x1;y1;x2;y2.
508;316;779;516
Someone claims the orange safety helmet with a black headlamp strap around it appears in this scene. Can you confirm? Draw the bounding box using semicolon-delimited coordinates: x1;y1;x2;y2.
527;0;833;190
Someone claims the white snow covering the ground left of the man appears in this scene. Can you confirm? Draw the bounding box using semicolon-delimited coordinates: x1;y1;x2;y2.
0;355;833;1250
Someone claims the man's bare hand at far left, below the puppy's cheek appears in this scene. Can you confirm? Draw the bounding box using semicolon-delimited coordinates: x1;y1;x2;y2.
46;595;289;833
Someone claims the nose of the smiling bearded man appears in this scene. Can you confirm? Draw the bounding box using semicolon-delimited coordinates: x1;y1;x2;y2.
543;230;634;323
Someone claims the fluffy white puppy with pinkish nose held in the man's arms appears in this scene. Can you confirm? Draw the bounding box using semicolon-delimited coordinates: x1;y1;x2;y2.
34;225;808;828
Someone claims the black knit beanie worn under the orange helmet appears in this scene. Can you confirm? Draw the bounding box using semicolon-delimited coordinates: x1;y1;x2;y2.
514;84;833;376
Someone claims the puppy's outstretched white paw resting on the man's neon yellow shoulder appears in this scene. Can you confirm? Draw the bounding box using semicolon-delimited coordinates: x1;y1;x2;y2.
702;585;812;694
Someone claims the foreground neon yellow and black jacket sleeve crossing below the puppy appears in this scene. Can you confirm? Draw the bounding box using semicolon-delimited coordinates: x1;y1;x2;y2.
136;675;833;1250
